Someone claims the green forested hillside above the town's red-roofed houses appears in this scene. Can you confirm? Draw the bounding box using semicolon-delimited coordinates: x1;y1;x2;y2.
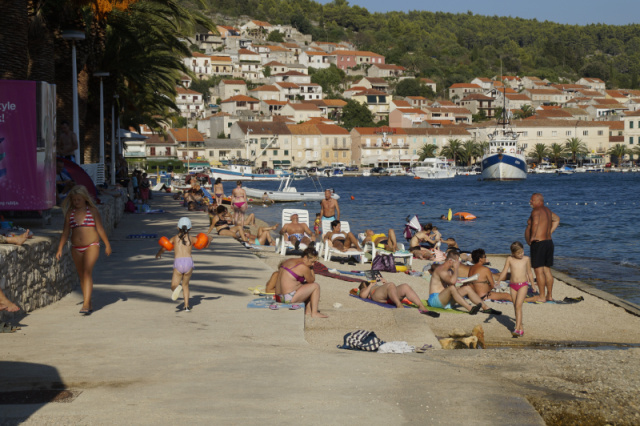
198;0;640;89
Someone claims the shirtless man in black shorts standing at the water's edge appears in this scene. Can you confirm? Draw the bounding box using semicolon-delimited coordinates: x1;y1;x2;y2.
524;193;560;302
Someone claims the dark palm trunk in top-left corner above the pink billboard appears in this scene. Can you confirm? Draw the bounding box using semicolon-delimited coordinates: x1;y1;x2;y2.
0;0;29;80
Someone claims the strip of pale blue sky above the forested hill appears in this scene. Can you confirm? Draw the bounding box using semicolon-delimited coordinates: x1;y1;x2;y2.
320;0;640;25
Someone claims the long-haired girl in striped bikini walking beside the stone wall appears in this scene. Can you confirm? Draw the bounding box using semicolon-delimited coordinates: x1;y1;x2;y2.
56;185;111;315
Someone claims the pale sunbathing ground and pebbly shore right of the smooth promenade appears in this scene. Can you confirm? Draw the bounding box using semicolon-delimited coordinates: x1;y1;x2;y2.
250;218;640;425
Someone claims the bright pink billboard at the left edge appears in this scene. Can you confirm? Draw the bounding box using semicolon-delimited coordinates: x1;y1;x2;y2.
0;80;55;210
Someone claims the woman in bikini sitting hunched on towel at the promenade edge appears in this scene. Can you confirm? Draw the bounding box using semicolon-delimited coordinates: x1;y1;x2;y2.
275;247;327;318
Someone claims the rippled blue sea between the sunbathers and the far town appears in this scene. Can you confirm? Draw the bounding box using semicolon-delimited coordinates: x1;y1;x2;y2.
244;173;640;304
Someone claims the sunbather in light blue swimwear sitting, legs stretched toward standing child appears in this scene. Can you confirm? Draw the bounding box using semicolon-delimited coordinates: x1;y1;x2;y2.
428;250;502;315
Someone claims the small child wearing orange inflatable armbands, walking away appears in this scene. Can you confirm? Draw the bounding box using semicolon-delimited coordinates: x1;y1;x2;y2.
156;217;197;312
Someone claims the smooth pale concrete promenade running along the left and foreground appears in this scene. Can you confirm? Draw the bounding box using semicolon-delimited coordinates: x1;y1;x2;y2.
0;194;544;425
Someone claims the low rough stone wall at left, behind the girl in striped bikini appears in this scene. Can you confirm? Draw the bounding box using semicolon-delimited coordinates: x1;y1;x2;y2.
0;194;126;321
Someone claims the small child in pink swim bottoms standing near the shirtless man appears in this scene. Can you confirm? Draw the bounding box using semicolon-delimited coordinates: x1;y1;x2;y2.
498;241;533;337
